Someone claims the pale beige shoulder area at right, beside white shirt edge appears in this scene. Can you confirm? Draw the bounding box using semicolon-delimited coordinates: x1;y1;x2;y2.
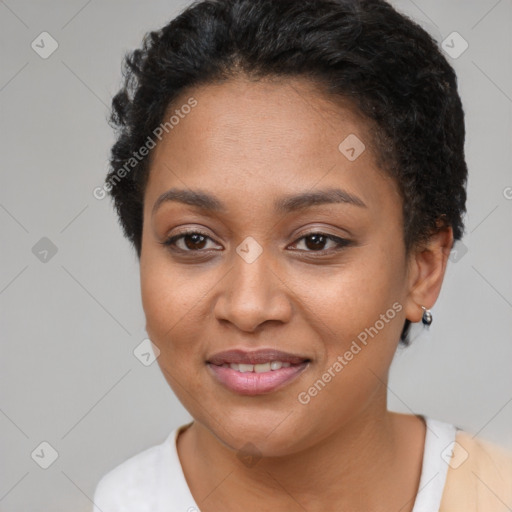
440;431;512;512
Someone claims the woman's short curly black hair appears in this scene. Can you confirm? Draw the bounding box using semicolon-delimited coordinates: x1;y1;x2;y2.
102;0;467;345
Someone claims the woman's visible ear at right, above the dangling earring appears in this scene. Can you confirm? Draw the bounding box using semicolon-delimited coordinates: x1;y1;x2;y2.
405;227;453;322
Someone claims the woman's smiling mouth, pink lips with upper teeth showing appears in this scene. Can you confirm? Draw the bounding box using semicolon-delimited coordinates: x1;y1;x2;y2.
206;349;311;395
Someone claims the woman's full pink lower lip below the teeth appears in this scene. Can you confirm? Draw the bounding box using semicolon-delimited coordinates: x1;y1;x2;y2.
207;362;309;395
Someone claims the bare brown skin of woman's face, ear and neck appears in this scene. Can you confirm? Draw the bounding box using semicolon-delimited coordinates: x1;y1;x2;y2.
140;78;453;512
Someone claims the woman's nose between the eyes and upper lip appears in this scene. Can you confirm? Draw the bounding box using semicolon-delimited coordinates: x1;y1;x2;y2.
214;247;293;332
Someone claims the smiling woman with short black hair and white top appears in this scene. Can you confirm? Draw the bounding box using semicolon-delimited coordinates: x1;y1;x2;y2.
94;0;512;512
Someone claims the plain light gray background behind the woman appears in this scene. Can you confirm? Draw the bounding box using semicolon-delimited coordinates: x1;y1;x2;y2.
0;0;512;512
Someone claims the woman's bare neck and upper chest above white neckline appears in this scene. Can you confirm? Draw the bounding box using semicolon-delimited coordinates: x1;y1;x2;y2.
178;397;424;512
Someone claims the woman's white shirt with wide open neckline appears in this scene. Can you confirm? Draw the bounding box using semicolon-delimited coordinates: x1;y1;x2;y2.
93;417;457;512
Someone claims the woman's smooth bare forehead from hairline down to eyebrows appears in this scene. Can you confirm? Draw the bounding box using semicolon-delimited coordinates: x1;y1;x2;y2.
145;79;398;216
